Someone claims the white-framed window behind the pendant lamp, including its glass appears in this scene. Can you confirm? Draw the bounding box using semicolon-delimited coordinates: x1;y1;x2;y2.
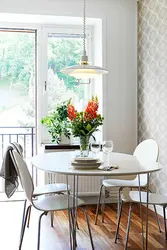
41;28;92;142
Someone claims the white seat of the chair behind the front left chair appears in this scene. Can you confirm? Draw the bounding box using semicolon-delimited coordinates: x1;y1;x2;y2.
33;183;70;197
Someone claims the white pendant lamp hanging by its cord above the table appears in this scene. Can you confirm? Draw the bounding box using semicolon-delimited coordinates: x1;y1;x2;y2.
61;0;108;83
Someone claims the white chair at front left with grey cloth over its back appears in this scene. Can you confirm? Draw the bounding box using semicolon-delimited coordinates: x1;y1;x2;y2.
11;150;94;250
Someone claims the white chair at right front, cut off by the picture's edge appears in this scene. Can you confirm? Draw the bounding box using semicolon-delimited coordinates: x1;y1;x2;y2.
115;191;167;249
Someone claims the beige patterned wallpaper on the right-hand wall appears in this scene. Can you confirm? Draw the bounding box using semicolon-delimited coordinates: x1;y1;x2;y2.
138;0;167;194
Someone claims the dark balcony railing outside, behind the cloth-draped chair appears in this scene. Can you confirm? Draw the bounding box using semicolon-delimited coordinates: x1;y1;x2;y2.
0;127;35;192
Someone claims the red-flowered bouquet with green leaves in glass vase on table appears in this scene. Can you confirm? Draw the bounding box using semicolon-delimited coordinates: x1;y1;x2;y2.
67;96;104;156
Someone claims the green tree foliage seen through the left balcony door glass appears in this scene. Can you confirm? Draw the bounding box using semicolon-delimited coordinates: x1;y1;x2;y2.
0;32;35;88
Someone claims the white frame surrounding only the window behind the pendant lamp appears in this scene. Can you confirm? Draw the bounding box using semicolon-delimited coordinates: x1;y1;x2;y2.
37;25;94;144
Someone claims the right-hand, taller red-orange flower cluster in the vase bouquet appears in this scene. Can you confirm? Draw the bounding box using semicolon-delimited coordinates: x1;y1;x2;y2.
85;98;99;121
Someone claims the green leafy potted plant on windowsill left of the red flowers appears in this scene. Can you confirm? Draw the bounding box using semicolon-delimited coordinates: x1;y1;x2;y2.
41;101;71;144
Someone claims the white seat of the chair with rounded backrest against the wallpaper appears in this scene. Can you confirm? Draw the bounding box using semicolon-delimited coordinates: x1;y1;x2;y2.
102;178;146;187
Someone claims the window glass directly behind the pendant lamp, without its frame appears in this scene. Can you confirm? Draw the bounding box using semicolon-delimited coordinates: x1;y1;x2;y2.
48;33;90;112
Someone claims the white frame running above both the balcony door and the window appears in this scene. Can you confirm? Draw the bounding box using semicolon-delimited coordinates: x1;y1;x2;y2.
0;22;104;146
